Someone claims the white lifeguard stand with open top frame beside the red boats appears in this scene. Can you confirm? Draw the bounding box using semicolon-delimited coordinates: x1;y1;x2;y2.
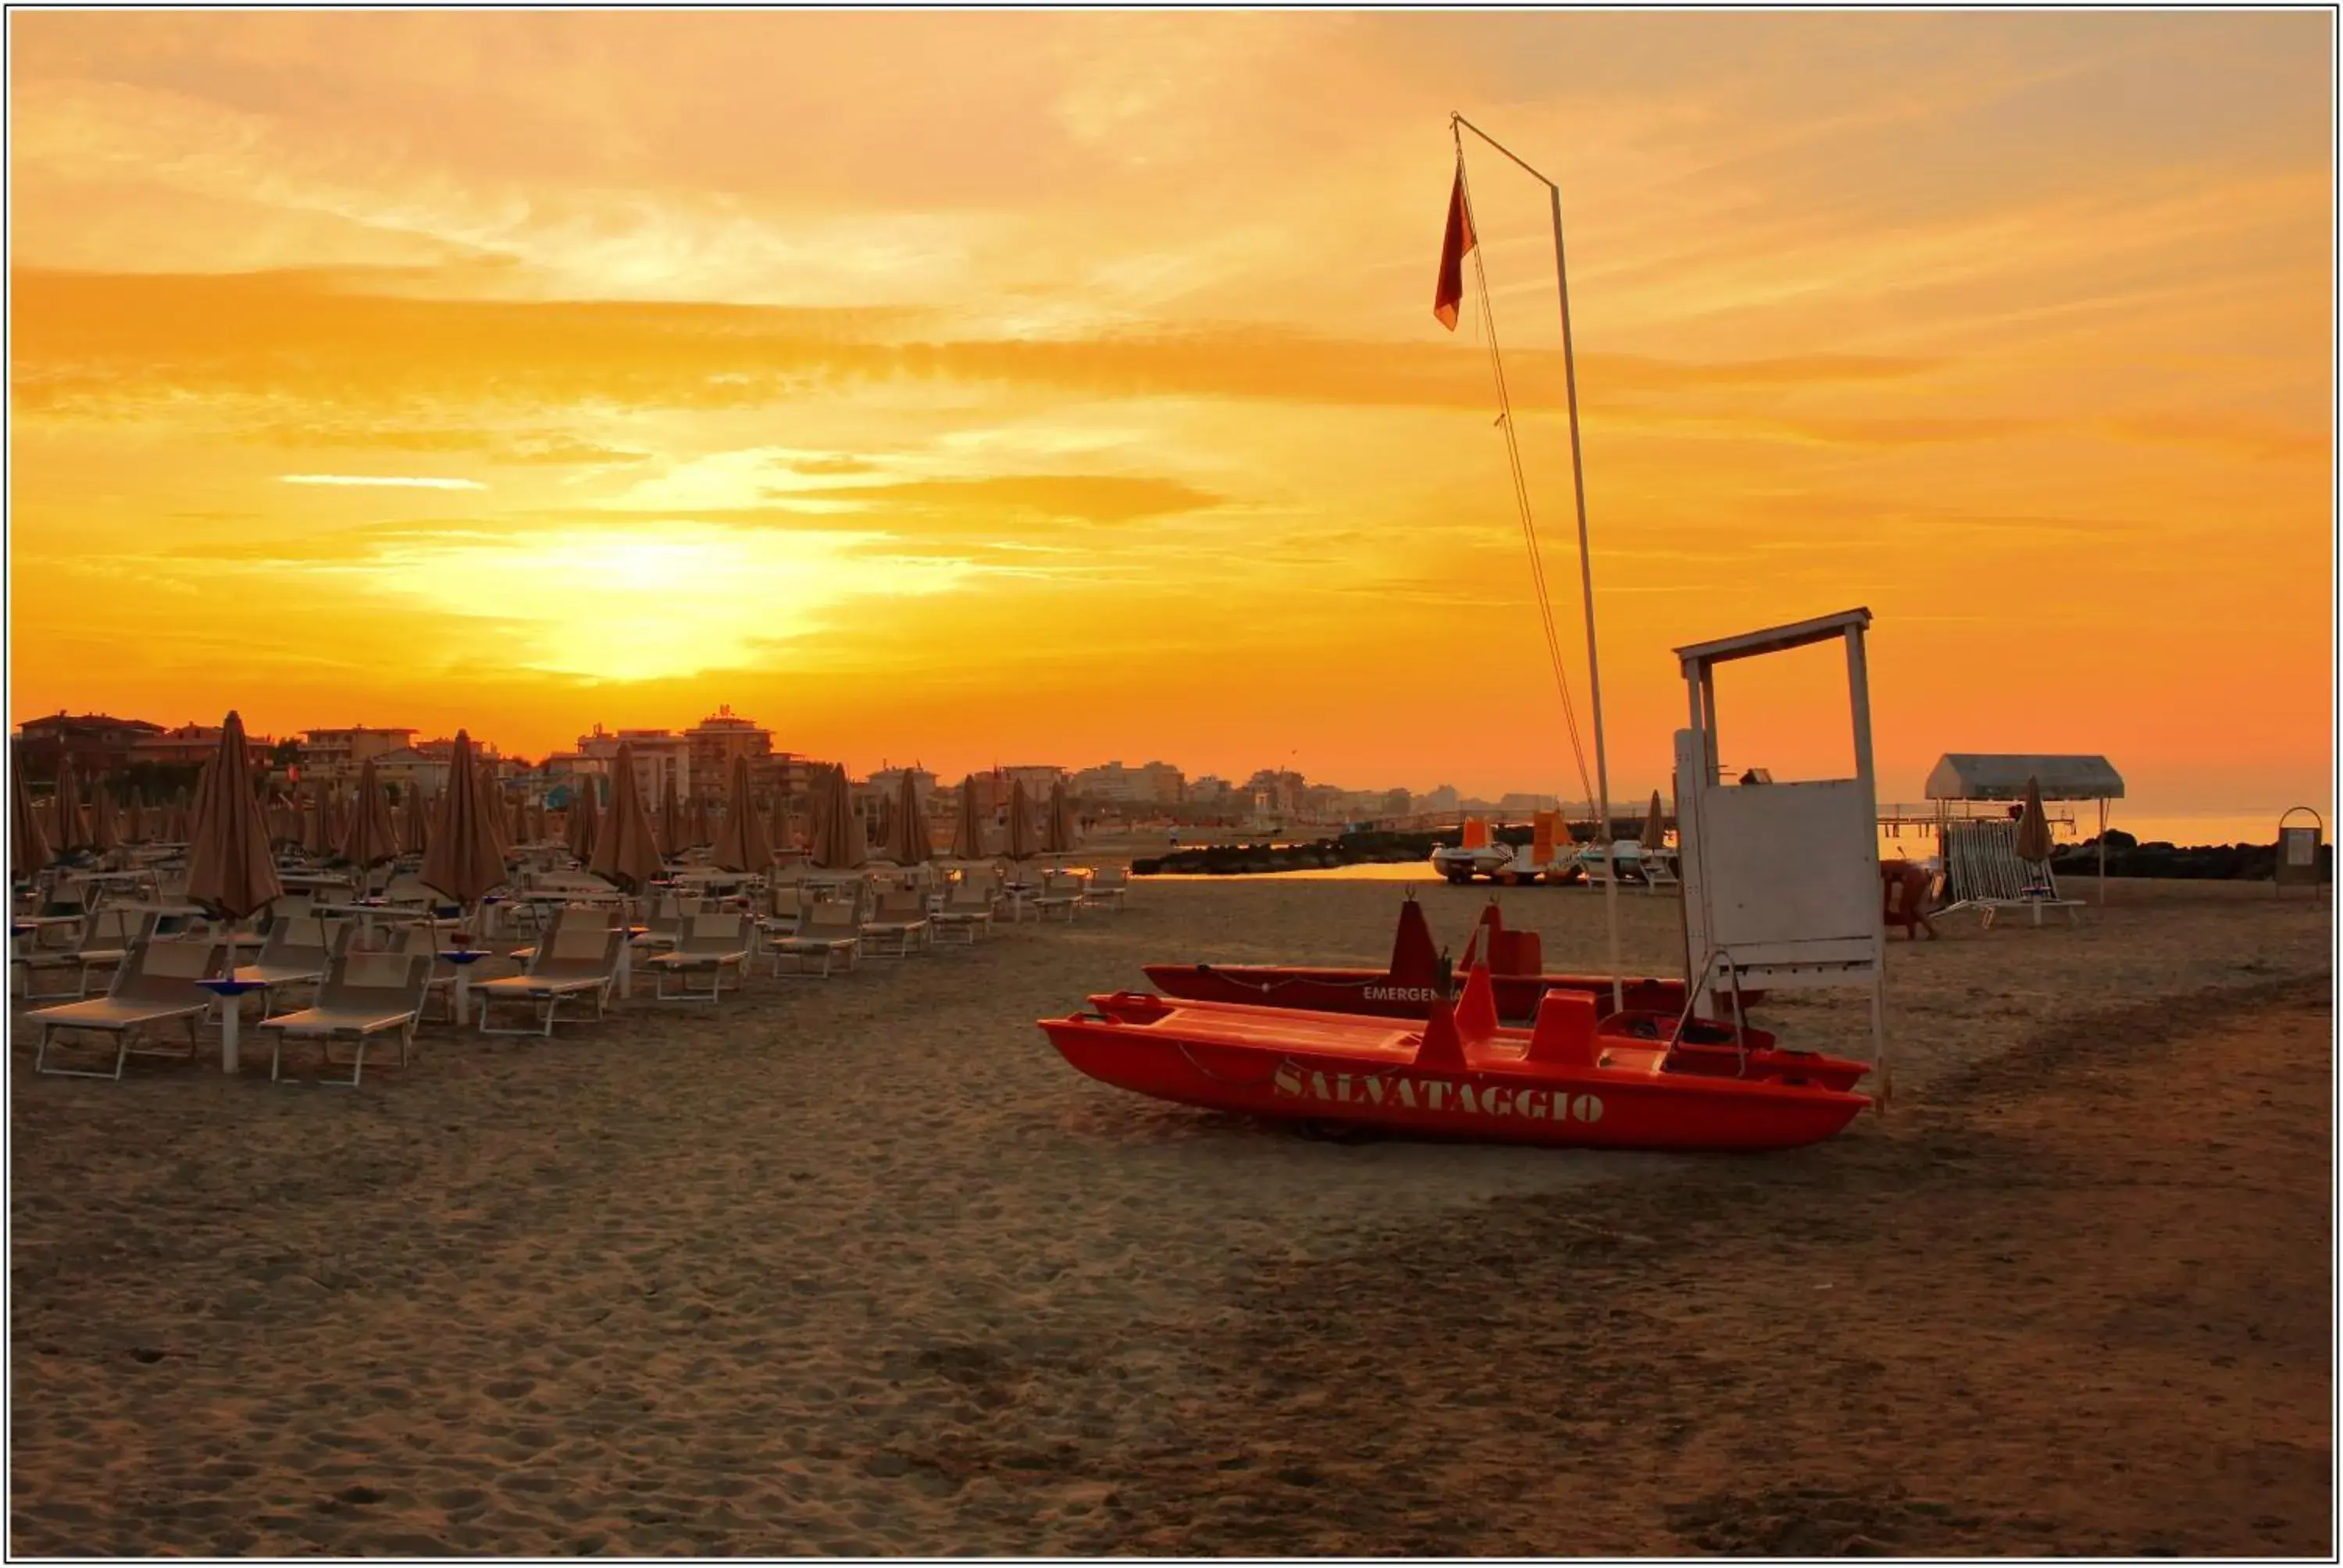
1675;609;1886;1099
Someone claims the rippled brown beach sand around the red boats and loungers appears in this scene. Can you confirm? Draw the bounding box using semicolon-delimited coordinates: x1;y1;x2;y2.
9;882;2331;1554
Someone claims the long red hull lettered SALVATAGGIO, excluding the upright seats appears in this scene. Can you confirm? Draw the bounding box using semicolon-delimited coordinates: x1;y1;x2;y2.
1040;1010;1870;1153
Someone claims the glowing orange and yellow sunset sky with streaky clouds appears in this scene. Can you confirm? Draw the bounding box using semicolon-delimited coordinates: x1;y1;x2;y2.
9;12;2334;811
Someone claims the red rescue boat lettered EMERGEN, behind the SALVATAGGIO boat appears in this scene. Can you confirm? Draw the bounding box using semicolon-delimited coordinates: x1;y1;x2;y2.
1143;896;1764;1025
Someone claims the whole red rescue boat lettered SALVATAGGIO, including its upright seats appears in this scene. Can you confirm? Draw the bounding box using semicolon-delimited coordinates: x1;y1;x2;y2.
1040;968;1872;1151
